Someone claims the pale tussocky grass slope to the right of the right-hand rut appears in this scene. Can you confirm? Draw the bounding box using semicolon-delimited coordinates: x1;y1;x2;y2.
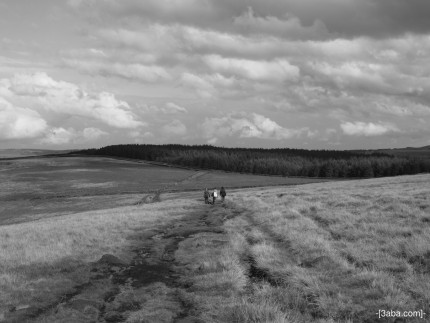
215;175;430;322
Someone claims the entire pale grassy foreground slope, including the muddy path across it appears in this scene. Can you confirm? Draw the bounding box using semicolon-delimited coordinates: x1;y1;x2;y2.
0;175;430;323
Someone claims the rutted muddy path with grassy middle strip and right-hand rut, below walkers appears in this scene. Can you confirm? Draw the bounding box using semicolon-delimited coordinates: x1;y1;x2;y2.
7;190;306;323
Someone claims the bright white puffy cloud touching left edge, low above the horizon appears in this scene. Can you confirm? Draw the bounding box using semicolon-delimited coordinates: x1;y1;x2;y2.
0;97;47;140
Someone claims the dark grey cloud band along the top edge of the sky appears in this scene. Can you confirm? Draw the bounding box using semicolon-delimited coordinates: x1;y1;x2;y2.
71;0;430;37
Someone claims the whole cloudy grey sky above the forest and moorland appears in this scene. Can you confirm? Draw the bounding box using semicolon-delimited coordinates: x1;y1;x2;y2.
0;0;430;149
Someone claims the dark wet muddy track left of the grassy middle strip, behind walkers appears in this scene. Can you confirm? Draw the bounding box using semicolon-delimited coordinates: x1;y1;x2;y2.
8;200;225;323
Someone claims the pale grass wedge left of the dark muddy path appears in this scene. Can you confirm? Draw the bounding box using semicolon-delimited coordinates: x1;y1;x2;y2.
0;200;197;310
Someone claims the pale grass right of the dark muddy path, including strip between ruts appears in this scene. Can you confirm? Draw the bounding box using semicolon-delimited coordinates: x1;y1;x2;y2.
170;175;430;323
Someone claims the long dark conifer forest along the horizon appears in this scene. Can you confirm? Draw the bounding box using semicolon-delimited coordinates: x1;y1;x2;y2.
79;144;430;177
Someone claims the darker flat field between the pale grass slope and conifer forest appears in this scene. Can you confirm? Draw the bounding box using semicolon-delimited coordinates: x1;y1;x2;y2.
0;157;330;225
